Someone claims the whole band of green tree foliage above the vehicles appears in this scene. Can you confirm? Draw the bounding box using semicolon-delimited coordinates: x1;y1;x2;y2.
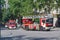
1;0;60;20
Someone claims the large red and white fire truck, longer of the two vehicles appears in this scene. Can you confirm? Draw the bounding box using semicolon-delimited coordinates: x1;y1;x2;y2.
22;18;53;31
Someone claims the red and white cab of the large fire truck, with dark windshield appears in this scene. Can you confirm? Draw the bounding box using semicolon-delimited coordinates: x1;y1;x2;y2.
40;18;53;30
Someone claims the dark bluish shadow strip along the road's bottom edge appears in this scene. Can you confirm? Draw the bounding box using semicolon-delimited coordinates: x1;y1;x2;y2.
0;35;60;40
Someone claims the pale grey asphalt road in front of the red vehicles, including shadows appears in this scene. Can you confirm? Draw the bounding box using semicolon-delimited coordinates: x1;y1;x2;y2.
0;28;60;40
